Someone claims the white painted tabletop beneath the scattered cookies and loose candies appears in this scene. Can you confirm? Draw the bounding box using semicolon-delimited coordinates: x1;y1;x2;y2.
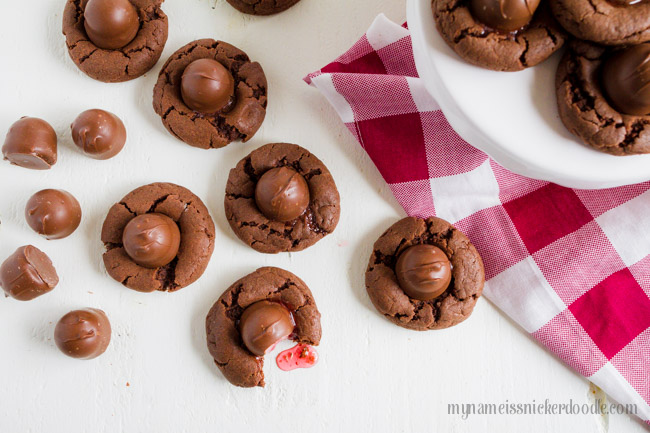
0;0;644;433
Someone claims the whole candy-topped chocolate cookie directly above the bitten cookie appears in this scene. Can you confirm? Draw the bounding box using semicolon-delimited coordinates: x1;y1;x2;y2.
224;143;341;254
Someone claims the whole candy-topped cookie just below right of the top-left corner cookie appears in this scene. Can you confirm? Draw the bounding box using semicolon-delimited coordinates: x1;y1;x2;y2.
153;39;267;149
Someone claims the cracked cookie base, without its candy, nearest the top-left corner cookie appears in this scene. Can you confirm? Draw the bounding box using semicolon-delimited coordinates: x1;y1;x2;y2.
153;39;267;149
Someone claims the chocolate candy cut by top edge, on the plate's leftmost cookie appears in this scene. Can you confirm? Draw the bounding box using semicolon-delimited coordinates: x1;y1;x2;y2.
470;0;540;32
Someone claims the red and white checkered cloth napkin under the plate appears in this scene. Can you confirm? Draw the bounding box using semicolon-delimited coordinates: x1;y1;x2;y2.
305;15;650;425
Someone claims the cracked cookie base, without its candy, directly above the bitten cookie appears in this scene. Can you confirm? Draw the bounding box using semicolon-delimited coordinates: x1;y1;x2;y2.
224;143;341;254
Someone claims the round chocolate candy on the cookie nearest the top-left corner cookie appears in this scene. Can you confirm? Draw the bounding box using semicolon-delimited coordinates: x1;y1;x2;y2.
181;59;235;114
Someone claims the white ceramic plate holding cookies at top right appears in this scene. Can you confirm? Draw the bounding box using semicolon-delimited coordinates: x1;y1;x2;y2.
407;0;650;189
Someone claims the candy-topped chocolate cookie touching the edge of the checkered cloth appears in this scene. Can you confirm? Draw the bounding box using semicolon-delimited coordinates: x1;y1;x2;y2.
366;217;485;331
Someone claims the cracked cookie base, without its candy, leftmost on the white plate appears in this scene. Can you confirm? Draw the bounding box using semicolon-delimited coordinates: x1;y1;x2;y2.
432;0;566;71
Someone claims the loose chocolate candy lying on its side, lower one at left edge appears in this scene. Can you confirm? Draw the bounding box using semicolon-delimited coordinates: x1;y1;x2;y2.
0;245;59;301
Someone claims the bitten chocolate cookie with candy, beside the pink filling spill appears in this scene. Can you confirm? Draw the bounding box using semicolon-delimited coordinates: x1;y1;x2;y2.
205;267;321;388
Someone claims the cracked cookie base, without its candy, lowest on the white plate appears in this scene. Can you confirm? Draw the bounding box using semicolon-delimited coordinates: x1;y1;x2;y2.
555;40;650;155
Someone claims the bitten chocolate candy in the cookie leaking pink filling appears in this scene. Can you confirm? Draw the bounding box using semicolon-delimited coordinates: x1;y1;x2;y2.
239;301;295;356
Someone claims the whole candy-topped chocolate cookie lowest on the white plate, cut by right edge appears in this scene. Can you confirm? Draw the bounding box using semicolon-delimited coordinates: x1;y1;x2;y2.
555;40;650;155
